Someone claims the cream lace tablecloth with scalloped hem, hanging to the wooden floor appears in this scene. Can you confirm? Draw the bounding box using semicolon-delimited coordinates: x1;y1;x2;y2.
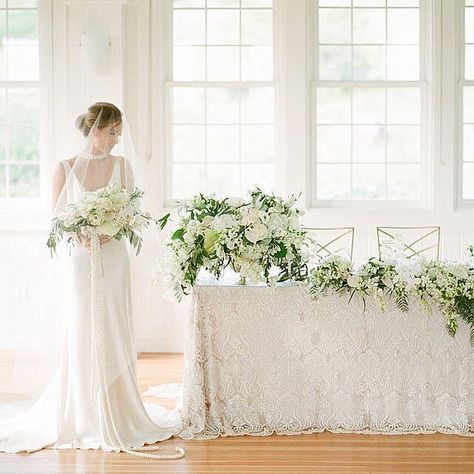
181;286;474;438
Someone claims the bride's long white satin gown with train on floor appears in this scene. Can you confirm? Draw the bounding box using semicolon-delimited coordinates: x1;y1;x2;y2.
0;158;181;453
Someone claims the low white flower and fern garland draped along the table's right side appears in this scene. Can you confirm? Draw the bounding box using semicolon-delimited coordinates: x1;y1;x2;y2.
308;246;474;345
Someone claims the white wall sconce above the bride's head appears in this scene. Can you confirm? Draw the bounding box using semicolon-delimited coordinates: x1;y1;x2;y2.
80;32;112;76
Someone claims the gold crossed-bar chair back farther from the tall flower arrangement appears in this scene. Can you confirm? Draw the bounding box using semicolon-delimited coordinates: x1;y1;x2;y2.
377;226;440;260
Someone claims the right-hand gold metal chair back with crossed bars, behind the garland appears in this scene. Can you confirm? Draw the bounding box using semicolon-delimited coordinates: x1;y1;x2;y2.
377;226;441;260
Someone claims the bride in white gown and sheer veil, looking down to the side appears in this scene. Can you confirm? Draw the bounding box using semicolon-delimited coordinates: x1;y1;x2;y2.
0;102;184;459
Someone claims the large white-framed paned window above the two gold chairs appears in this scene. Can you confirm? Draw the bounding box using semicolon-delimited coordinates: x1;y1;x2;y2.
312;0;426;205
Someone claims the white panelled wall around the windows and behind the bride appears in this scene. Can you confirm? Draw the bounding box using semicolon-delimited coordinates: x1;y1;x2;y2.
0;0;474;352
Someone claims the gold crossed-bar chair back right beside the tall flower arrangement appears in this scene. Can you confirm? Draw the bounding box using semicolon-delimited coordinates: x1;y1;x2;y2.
304;227;354;261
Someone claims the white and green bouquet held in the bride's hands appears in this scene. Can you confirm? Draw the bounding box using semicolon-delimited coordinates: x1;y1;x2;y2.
47;185;155;255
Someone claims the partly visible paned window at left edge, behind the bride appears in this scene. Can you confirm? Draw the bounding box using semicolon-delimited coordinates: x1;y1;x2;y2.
0;0;40;198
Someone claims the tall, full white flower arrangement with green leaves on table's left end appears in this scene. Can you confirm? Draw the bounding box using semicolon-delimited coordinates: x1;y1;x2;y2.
159;188;307;299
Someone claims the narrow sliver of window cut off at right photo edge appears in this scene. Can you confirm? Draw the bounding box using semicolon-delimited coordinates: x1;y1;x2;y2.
461;0;474;199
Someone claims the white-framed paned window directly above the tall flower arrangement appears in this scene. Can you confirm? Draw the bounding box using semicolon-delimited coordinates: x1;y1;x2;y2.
166;0;275;200
